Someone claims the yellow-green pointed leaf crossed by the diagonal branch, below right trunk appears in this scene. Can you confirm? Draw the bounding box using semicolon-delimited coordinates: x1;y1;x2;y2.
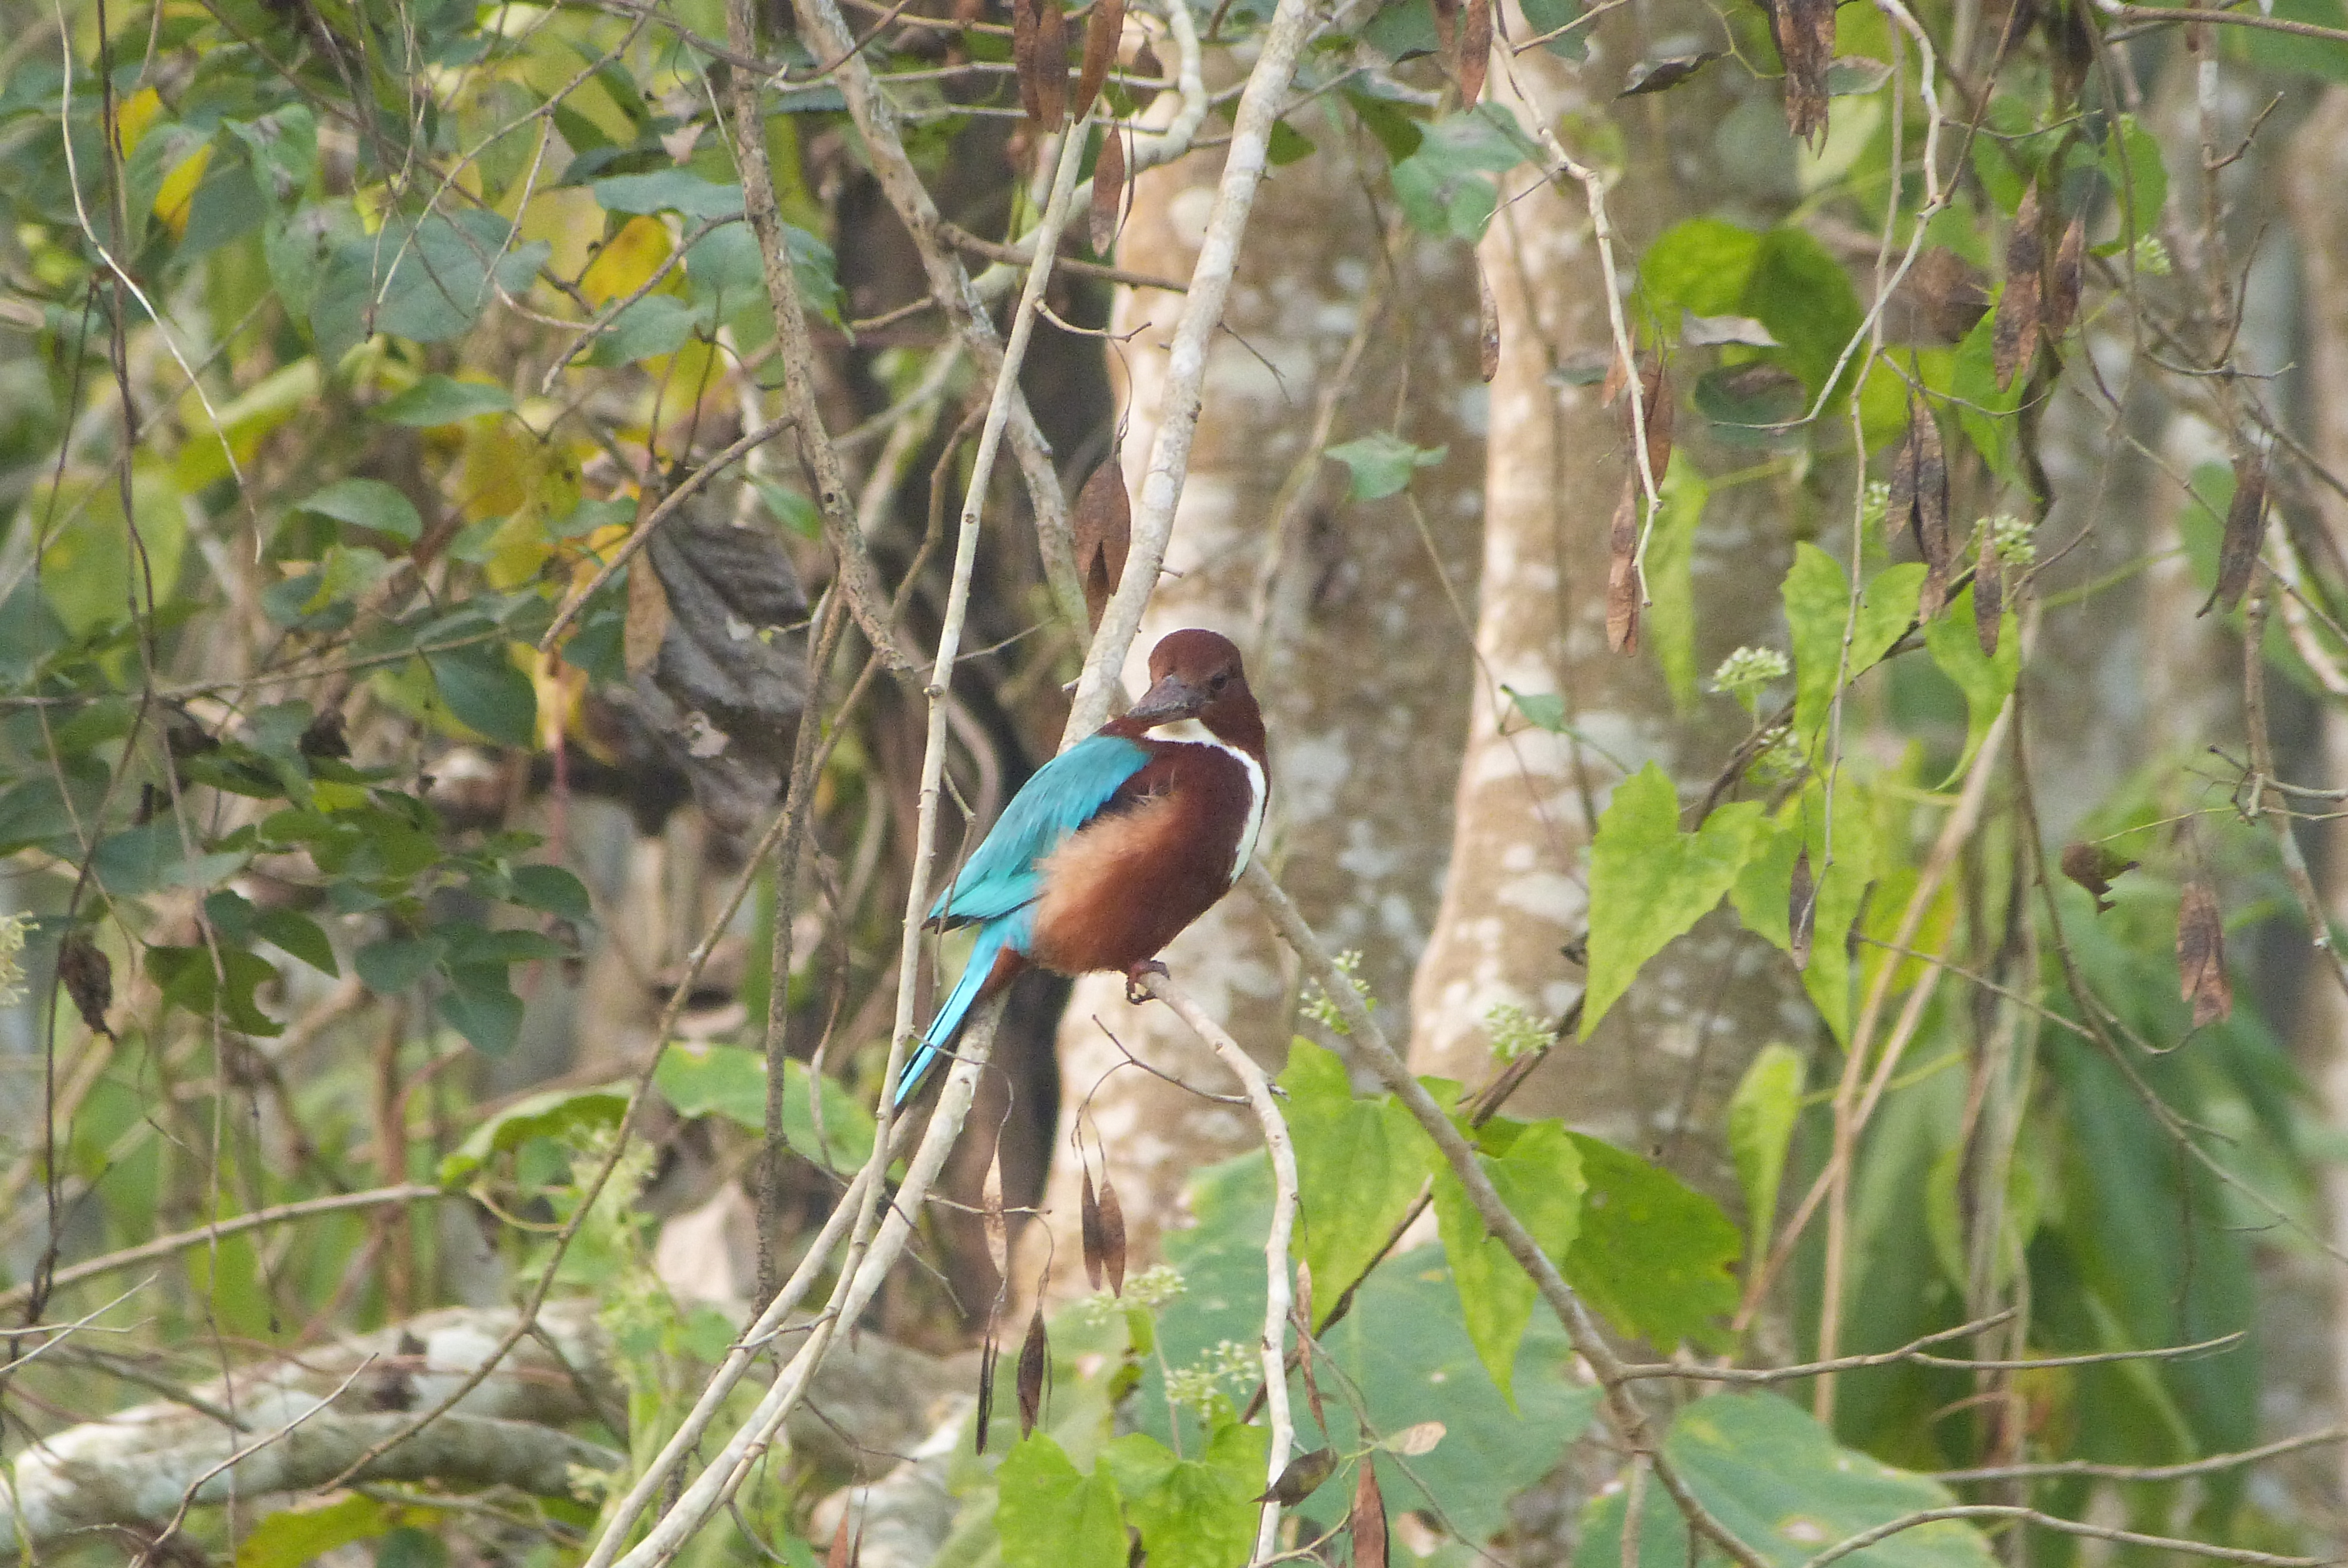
1435;1117;1583;1408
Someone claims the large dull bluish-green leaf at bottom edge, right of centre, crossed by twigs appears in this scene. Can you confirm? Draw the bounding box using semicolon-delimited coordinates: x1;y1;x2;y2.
1573;1394;1998;1568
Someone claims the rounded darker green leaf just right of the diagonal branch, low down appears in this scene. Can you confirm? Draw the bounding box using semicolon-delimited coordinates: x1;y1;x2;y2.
1566;1134;1745;1350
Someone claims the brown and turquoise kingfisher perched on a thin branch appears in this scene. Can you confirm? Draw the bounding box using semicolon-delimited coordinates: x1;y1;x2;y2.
895;627;1270;1106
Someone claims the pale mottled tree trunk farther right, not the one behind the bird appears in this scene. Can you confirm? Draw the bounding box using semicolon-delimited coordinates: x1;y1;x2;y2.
1411;36;1813;1197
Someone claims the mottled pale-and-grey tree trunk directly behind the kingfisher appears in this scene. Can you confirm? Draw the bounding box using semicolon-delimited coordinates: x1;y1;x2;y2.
1028;122;1484;1289
